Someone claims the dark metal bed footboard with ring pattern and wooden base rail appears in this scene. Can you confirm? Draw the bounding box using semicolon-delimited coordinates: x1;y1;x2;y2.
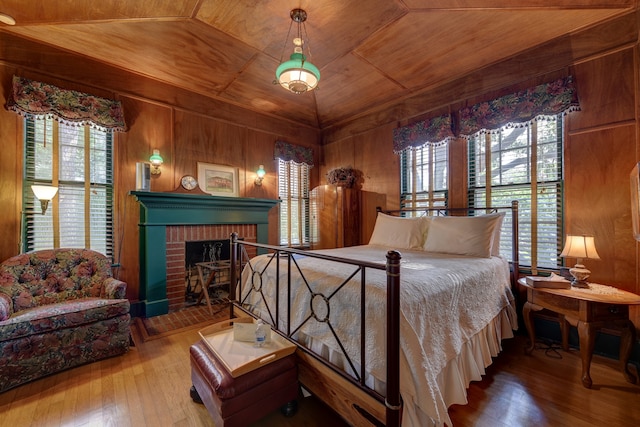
229;233;402;427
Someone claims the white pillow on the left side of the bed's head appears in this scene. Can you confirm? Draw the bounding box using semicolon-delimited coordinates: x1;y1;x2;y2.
369;212;429;249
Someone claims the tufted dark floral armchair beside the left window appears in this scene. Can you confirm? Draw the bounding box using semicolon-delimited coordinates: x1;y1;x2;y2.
0;249;130;392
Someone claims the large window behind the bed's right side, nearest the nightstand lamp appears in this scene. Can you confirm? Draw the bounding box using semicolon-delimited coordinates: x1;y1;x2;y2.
469;115;563;268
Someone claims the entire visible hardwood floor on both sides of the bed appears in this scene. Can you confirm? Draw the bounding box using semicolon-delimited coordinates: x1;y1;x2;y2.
0;329;640;427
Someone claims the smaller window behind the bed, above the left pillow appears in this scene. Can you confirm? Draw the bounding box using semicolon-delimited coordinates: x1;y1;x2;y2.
400;144;449;208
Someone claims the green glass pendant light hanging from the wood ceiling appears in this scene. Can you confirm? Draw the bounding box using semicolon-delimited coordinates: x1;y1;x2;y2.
275;9;320;94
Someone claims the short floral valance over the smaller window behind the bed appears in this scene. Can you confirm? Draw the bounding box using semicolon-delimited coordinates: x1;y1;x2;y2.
393;114;455;153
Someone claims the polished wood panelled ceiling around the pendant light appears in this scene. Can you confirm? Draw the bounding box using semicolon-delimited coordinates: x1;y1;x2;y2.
0;0;636;129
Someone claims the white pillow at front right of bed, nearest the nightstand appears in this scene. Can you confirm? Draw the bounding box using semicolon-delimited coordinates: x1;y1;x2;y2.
424;213;504;258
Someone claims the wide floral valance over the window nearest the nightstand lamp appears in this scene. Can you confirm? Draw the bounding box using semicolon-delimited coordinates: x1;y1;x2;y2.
458;76;580;138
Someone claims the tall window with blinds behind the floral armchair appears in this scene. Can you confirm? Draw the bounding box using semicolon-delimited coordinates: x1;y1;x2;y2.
22;118;113;256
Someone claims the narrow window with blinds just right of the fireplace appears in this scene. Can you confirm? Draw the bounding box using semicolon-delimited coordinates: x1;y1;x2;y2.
278;159;309;247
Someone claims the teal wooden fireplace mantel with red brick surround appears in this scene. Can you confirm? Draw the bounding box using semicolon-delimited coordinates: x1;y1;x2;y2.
130;191;278;317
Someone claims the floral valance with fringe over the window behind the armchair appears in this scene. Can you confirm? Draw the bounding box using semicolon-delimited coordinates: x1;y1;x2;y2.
7;76;126;132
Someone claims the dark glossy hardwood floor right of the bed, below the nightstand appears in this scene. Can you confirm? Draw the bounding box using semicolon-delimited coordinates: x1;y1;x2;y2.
449;337;640;427
